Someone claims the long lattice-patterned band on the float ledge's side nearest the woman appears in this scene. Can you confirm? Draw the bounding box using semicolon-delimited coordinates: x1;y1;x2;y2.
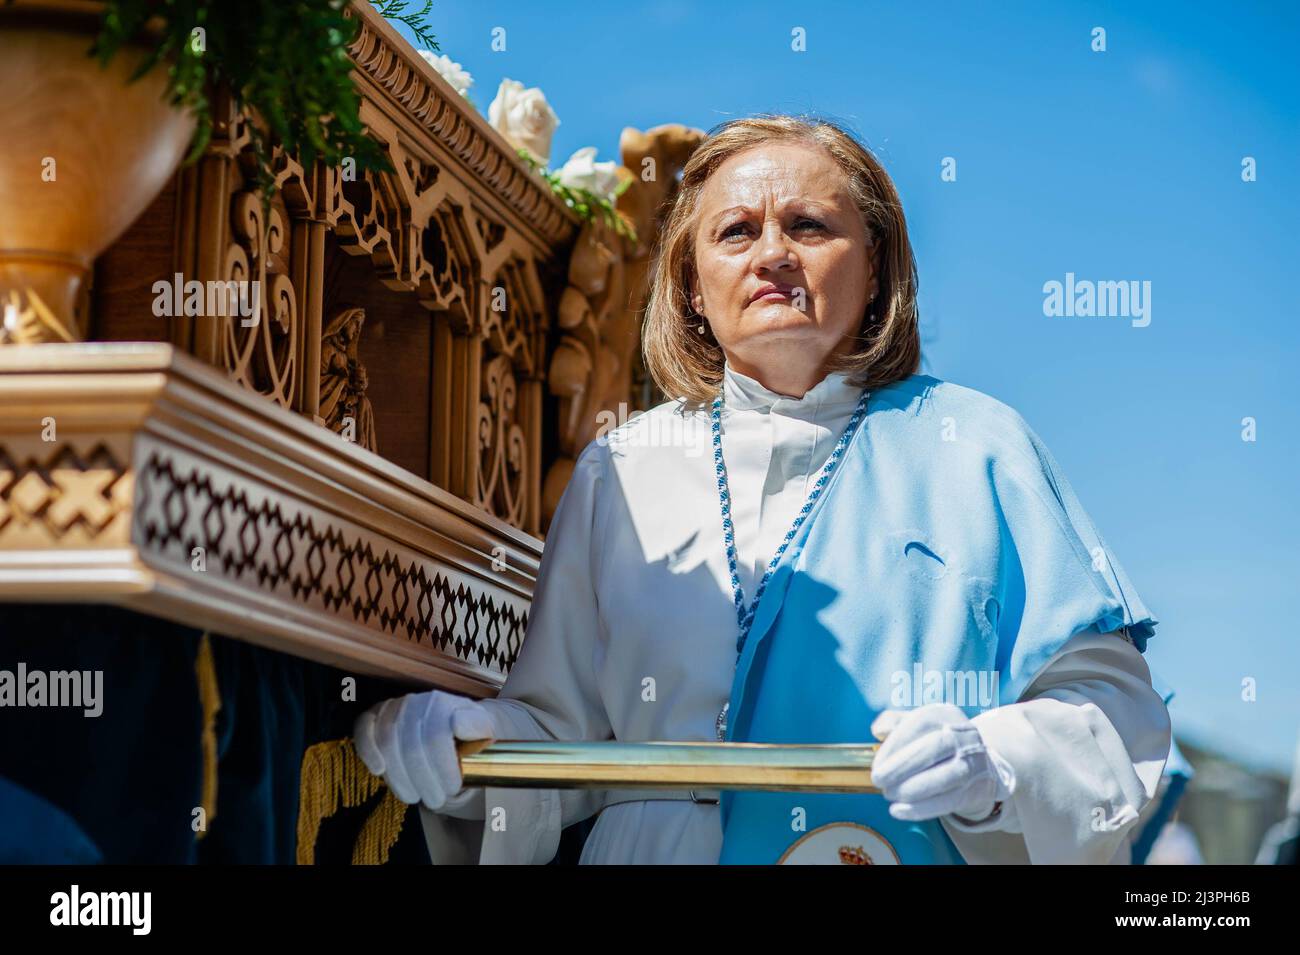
133;442;527;673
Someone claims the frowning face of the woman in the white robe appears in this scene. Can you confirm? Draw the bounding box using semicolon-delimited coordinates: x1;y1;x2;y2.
692;142;876;394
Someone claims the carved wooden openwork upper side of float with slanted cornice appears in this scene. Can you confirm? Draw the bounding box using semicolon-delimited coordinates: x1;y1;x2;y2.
150;4;579;534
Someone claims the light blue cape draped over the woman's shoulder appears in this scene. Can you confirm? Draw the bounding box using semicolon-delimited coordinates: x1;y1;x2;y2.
720;374;1158;864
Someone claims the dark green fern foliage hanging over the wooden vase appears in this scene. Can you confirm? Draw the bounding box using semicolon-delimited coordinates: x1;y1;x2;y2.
90;0;433;201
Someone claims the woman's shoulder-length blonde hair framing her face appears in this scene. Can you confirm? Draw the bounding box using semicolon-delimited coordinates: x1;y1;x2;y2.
641;114;920;403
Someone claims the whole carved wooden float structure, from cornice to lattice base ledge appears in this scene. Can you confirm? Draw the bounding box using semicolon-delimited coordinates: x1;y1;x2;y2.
0;4;701;694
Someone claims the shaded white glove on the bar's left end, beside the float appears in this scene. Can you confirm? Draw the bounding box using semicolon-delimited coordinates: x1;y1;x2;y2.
352;690;494;812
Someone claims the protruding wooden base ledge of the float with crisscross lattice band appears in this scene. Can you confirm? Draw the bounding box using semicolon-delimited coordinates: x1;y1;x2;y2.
0;343;542;696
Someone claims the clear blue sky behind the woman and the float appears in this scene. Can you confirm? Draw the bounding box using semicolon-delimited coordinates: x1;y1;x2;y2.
392;1;1300;770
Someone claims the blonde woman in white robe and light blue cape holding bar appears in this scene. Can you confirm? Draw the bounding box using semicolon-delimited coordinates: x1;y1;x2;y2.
356;117;1170;863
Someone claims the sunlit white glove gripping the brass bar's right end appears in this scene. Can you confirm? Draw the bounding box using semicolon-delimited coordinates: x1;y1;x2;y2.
871;703;1015;822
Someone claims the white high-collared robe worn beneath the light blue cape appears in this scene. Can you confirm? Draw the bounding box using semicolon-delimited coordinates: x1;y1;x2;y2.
421;365;1170;864
